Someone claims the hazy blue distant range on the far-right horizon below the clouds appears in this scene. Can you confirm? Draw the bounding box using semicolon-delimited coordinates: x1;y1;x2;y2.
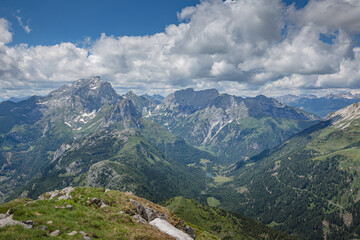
276;92;360;118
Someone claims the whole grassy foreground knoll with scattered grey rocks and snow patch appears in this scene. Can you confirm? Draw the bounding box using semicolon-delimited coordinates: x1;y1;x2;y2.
0;187;217;240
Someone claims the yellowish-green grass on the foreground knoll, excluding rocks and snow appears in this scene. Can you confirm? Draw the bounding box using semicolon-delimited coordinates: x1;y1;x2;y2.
0;188;216;240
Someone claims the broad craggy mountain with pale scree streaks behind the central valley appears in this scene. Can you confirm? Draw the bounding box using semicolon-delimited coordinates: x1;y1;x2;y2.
148;89;318;162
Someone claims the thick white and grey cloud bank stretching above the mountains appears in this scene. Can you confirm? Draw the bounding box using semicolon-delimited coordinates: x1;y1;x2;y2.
0;0;360;96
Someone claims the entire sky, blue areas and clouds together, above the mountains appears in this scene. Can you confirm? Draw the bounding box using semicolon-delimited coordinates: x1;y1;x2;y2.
0;0;360;100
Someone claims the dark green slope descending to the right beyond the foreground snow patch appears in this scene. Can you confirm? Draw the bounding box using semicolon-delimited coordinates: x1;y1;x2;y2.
162;197;295;239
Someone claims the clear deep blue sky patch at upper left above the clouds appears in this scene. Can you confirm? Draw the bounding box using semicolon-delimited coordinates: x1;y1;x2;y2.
0;0;199;45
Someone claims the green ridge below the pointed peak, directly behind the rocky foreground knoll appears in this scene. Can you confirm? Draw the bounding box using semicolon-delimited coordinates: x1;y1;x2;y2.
18;128;205;205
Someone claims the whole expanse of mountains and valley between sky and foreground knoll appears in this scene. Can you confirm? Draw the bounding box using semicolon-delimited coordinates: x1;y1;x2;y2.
0;77;360;239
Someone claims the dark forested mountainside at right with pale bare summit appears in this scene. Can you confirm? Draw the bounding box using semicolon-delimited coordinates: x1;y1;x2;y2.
207;103;360;239
